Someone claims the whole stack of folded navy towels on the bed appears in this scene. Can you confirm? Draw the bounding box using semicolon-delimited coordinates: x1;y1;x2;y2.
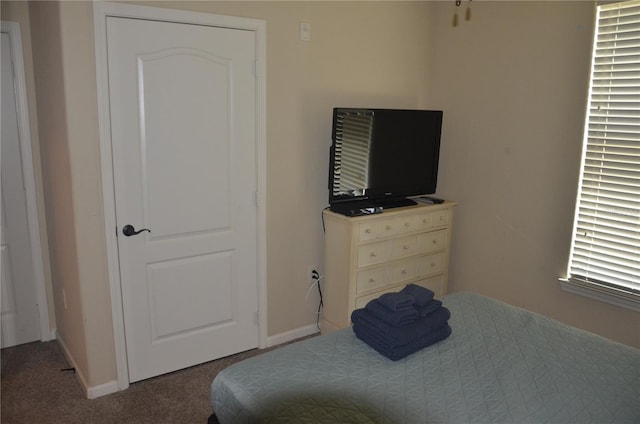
351;284;451;361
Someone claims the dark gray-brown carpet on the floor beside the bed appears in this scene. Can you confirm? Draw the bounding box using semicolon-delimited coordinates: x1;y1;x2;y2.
0;341;310;424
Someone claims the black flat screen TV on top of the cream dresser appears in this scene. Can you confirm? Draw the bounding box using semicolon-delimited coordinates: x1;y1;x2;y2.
329;108;443;211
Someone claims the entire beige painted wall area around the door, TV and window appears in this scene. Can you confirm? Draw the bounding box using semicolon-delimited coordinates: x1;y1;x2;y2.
3;2;640;385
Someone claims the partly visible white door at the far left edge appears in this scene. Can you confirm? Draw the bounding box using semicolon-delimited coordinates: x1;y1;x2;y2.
0;32;40;347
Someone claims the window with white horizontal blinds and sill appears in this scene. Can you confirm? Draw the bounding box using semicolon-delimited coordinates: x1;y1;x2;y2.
562;0;640;310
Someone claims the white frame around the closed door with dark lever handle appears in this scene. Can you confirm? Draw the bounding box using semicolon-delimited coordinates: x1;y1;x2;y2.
93;2;267;390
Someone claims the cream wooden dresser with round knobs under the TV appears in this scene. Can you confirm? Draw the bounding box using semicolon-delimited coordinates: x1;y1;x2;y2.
321;202;456;333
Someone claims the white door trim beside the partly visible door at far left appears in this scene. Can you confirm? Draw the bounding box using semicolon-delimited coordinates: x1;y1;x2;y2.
0;21;54;342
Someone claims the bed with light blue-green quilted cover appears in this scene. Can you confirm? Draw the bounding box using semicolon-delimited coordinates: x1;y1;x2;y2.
211;293;640;424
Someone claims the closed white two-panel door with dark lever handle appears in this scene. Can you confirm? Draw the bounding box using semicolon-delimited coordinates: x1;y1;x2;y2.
107;17;259;382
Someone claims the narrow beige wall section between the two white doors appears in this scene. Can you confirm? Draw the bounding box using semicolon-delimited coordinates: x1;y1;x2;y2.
30;2;115;386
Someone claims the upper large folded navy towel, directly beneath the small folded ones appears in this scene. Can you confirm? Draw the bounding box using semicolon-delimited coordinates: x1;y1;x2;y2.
351;306;451;346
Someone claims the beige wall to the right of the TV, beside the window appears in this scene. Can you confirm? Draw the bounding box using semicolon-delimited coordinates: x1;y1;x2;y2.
429;2;640;347
